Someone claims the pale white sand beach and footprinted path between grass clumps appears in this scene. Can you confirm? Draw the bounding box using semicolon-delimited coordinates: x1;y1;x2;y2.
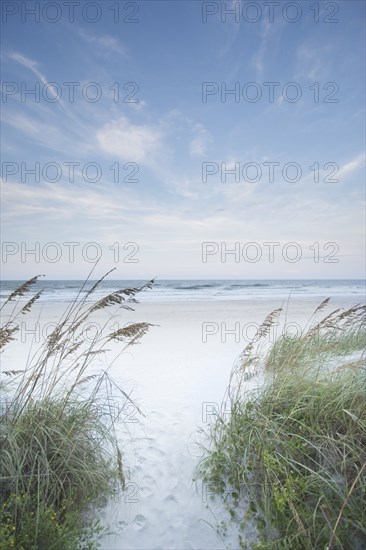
2;296;354;550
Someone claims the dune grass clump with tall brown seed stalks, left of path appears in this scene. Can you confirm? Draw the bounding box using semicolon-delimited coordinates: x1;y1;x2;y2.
0;277;152;550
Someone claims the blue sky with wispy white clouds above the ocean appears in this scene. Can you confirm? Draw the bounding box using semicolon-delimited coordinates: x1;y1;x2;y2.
1;0;365;279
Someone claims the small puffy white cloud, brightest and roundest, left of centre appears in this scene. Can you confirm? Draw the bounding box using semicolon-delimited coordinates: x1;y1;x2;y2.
97;117;162;162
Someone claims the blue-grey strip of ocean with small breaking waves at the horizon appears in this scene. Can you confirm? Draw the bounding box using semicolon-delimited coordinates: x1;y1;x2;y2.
0;279;366;303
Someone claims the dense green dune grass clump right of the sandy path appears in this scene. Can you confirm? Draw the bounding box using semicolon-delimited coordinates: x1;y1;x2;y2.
197;300;366;550
